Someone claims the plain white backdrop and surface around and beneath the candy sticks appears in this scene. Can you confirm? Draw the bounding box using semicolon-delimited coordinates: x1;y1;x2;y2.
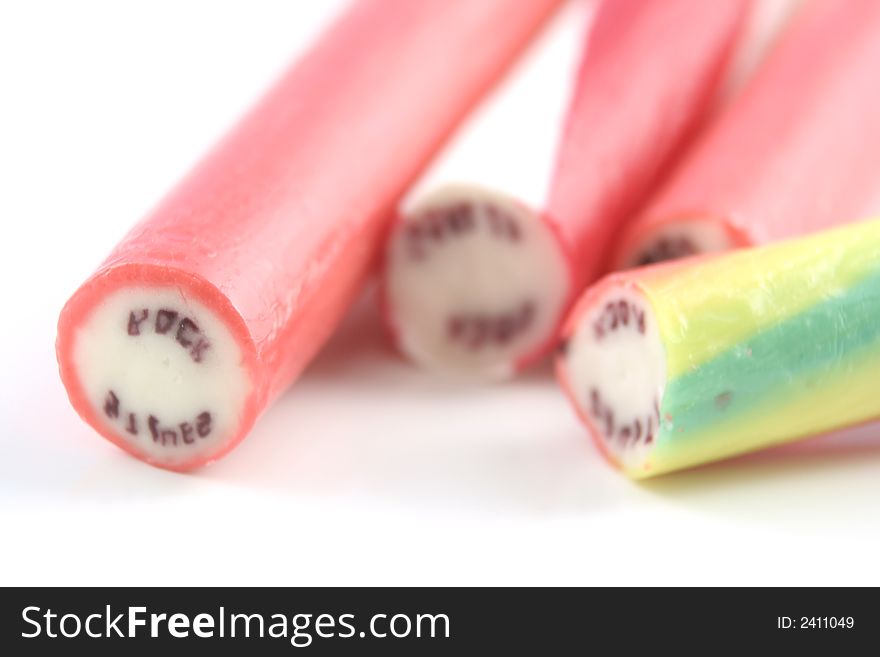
0;0;880;584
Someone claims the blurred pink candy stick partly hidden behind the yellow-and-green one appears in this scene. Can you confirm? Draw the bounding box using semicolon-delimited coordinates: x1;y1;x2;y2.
613;0;880;268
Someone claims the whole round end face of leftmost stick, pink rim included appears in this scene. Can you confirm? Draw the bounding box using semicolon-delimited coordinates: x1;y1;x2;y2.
56;265;260;471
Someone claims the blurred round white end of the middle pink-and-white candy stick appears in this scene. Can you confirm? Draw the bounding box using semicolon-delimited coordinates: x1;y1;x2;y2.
386;185;569;379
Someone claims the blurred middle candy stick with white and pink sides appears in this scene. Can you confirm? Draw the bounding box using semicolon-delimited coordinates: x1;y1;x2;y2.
383;0;749;379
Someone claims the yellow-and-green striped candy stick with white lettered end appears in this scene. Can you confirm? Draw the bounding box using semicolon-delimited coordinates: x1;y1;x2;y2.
557;222;880;477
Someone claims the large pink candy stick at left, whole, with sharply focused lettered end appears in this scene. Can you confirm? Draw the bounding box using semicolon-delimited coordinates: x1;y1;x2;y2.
57;0;558;470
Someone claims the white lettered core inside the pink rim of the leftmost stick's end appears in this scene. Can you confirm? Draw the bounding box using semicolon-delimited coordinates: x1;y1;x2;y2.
74;287;250;465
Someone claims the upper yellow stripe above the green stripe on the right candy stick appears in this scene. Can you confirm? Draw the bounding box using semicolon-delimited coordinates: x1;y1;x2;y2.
638;221;880;379
